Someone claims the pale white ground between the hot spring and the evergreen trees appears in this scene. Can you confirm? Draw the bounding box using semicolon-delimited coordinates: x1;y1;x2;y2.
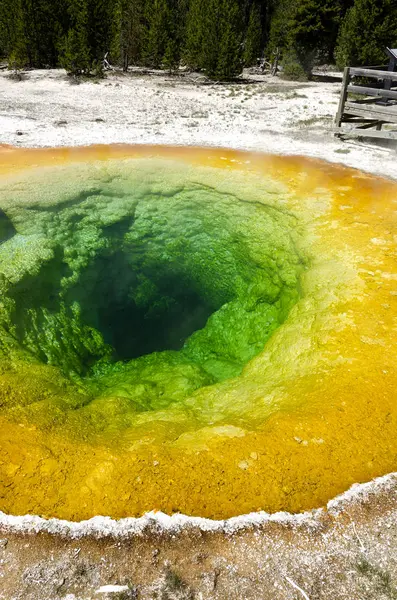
0;69;397;178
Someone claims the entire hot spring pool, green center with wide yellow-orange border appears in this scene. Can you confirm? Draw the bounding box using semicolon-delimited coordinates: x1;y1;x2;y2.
0;146;397;520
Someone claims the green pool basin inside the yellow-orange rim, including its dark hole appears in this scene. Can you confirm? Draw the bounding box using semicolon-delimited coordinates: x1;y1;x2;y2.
0;161;305;430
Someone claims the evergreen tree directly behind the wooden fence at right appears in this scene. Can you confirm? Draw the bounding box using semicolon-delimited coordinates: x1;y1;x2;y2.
335;0;397;68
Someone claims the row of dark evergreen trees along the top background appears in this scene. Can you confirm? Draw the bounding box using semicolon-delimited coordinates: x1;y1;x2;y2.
0;0;397;79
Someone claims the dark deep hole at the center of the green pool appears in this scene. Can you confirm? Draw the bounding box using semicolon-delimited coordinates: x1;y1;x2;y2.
67;248;219;360
